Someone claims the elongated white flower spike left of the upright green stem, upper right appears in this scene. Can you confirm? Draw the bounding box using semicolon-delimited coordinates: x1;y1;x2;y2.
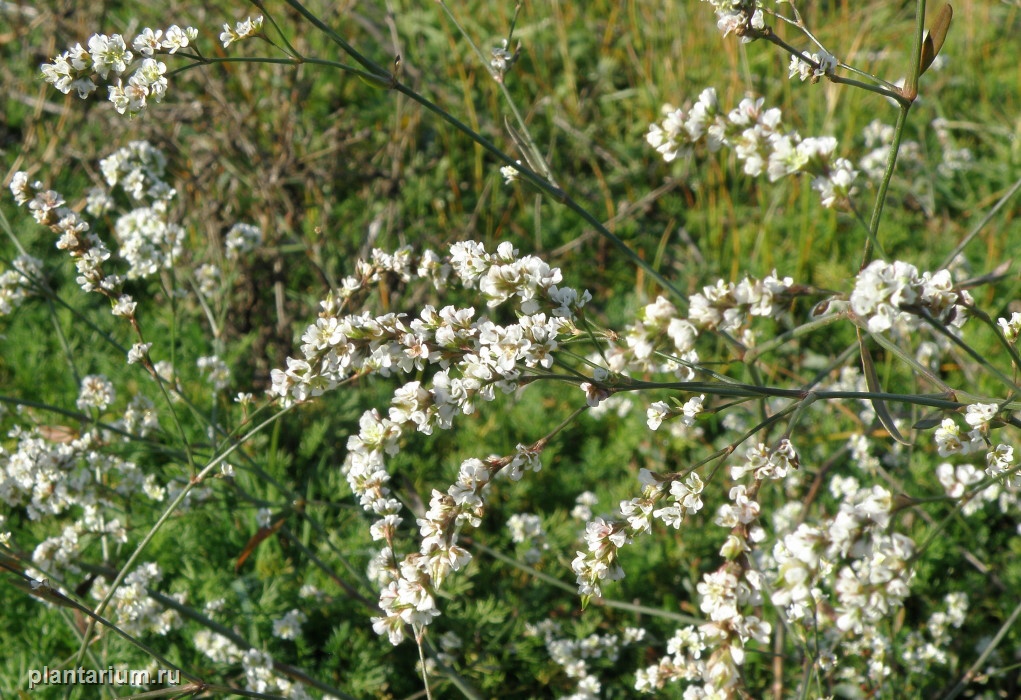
645;88;858;207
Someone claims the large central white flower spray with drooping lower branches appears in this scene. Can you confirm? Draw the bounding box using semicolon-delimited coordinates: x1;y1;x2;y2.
271;242;590;644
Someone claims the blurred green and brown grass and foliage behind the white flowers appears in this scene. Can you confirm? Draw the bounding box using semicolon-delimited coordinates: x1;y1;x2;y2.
0;0;1021;698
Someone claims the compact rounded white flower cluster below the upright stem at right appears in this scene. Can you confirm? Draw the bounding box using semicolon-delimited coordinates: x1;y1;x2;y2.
850;260;973;333
